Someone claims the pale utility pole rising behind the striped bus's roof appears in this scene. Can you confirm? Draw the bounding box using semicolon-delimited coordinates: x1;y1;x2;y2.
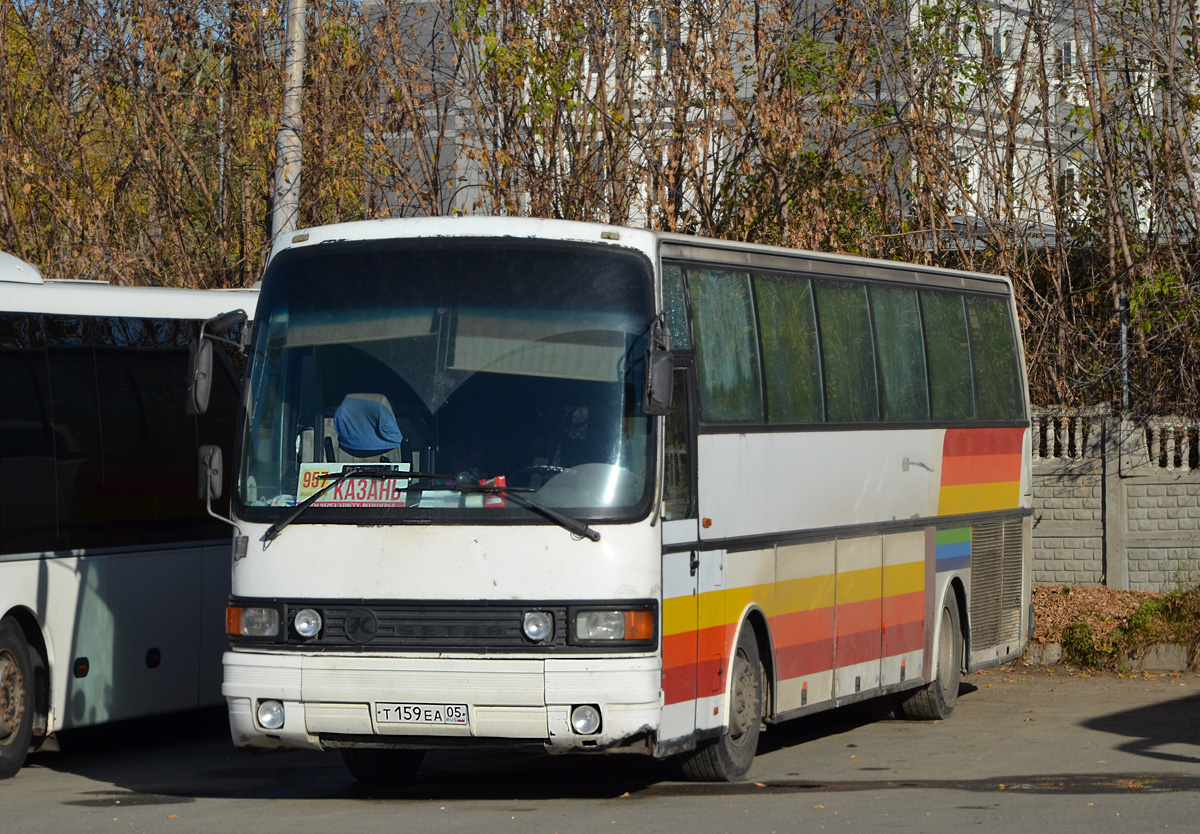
271;0;305;239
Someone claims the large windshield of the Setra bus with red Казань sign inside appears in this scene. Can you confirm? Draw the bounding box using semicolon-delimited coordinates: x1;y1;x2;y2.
235;238;653;524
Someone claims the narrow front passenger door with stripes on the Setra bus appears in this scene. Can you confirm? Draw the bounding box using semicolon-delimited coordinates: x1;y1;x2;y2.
658;369;701;744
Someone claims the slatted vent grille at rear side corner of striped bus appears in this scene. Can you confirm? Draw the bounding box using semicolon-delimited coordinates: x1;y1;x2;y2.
971;521;1024;650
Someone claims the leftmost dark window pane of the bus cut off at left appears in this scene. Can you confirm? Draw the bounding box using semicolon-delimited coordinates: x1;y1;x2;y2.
0;313;58;554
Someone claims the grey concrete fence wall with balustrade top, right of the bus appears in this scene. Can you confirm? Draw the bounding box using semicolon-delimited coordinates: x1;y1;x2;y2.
1031;408;1200;590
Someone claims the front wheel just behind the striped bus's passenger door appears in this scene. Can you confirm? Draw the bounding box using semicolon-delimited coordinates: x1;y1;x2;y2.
680;624;763;782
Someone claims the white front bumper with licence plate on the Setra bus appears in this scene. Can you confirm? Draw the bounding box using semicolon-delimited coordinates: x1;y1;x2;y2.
222;652;662;751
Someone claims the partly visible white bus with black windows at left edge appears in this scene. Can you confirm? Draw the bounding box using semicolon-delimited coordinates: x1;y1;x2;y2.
0;254;257;776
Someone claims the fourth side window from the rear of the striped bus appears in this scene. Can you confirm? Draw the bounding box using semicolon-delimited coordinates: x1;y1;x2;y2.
816;281;880;422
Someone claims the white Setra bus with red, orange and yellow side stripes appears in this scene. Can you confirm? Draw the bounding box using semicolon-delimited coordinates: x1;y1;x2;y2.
216;217;1031;782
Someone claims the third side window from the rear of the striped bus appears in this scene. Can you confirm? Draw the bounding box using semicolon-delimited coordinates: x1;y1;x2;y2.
871;287;929;421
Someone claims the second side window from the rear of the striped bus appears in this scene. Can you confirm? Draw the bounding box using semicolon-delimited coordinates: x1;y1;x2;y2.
920;290;974;420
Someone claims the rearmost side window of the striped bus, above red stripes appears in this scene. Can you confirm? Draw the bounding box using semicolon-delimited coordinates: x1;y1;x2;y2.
967;296;1025;420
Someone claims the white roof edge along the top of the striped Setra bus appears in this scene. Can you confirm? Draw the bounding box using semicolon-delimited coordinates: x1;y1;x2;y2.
268;215;1012;293
